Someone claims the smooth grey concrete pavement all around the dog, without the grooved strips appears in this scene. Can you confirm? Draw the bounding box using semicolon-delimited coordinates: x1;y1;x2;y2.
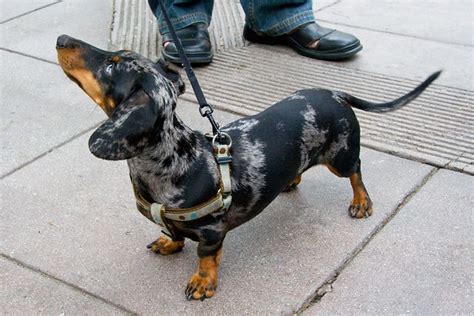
0;0;474;315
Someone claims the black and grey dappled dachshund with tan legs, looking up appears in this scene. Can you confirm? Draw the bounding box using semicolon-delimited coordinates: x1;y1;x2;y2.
56;35;440;300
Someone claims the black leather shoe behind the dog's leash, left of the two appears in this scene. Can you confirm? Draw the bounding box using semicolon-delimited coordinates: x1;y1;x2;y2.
161;23;213;64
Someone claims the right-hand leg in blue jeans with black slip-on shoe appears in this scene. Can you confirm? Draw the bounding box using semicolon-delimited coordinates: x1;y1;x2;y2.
241;0;362;60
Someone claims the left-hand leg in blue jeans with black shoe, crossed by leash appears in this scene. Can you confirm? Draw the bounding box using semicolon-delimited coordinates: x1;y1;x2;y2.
148;0;214;64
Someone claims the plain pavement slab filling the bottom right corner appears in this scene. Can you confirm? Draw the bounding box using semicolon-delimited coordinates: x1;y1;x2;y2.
305;170;474;315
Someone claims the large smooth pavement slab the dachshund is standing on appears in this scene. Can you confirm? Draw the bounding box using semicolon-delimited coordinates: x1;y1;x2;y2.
0;102;432;315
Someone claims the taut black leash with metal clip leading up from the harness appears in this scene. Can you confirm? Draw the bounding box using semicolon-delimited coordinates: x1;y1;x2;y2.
158;0;221;138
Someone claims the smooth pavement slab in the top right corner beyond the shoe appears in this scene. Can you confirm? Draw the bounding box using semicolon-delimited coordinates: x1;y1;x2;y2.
316;0;474;46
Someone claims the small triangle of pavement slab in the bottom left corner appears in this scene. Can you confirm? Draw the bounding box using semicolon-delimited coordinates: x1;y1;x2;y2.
0;257;128;315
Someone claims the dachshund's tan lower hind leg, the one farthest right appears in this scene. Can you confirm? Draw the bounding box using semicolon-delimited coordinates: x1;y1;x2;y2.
327;159;372;218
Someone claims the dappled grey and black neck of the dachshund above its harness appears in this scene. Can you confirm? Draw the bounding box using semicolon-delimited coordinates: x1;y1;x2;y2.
128;81;219;207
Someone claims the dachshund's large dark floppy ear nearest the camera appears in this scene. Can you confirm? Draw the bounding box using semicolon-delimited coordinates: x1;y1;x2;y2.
89;90;158;160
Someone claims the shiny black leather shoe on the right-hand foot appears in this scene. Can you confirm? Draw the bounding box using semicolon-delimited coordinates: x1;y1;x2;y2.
244;22;362;60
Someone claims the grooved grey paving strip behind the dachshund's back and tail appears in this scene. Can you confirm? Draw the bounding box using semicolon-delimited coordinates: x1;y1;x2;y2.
180;45;474;172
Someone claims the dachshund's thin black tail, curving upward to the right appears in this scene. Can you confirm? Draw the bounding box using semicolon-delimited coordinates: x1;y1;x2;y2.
337;71;441;113
